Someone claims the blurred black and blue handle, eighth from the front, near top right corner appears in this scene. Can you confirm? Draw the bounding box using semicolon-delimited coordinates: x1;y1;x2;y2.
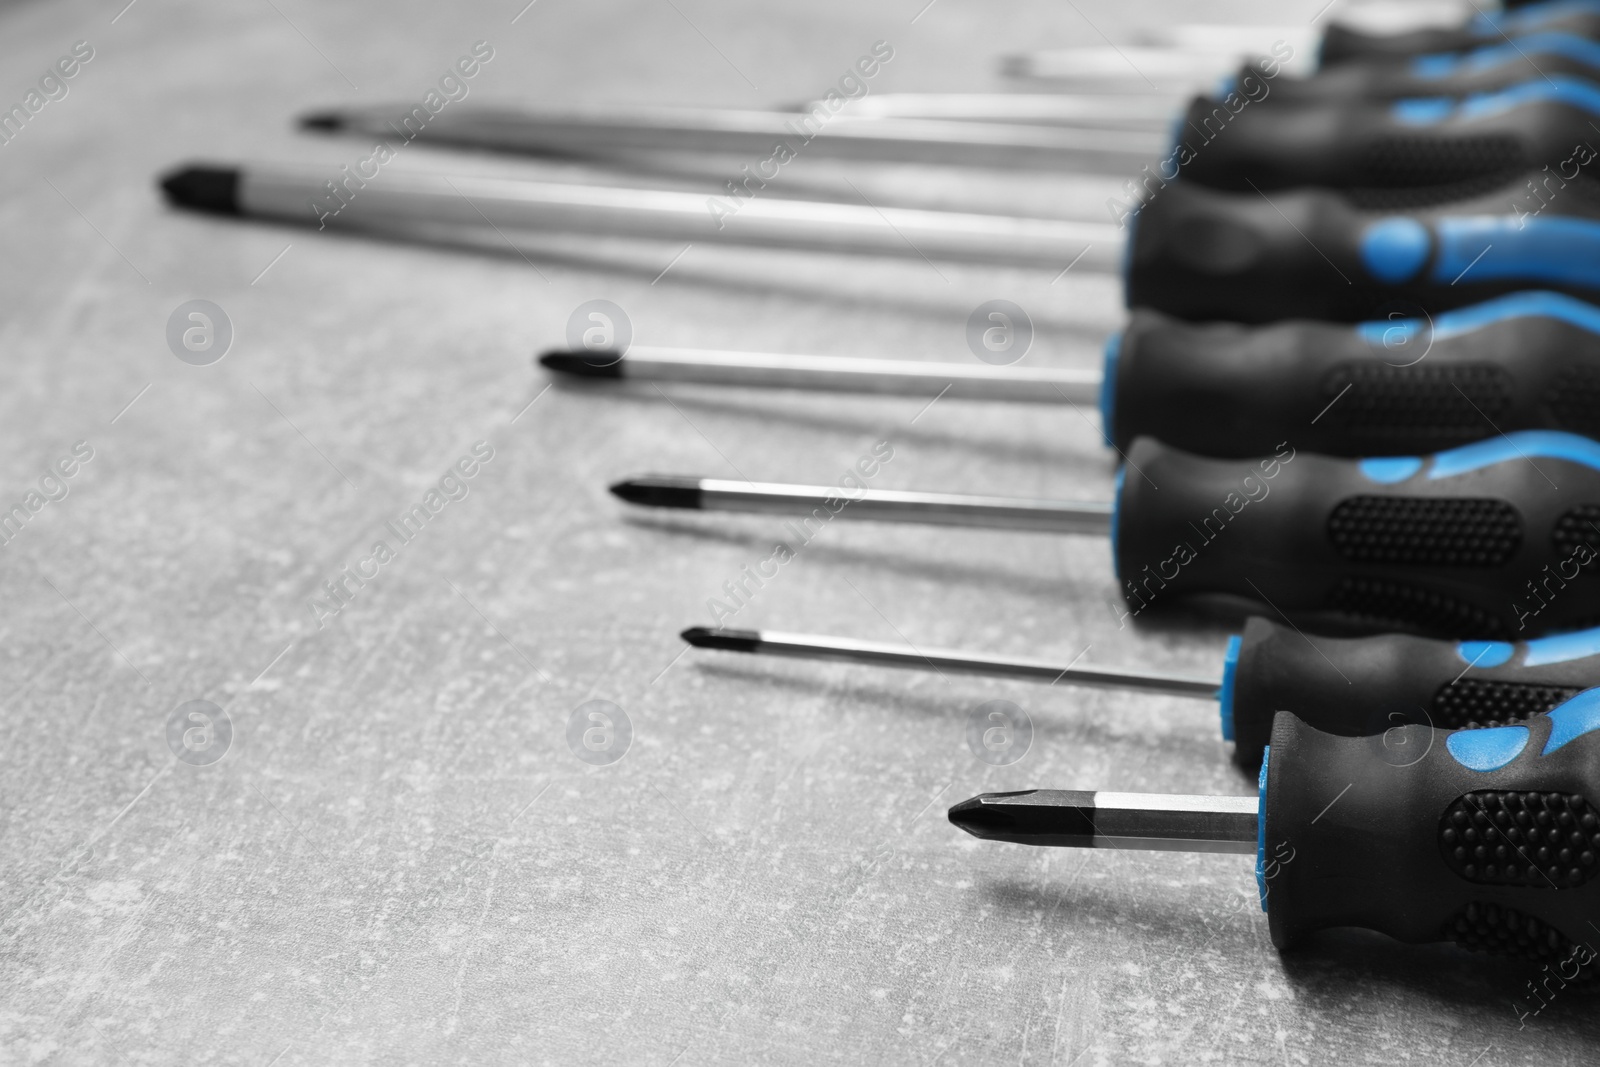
1318;0;1600;67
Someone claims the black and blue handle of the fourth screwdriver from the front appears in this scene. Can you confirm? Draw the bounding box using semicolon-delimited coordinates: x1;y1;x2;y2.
1101;294;1600;458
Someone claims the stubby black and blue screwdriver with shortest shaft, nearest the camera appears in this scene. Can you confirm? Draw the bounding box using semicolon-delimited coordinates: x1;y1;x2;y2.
949;700;1600;977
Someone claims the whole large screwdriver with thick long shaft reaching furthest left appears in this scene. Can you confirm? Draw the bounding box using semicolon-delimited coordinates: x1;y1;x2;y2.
162;157;1600;322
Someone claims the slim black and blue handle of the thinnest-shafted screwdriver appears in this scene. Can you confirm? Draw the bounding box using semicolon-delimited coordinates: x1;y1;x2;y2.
1221;617;1600;771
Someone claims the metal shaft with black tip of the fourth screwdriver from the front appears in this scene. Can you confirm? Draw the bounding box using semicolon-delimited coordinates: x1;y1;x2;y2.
544;346;1101;405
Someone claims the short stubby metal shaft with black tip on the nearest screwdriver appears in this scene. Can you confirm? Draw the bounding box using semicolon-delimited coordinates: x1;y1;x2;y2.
950;789;1261;853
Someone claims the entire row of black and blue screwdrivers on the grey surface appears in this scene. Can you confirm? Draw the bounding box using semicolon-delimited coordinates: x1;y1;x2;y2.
152;0;1600;976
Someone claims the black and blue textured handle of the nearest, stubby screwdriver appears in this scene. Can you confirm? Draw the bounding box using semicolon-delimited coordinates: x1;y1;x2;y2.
1258;703;1600;981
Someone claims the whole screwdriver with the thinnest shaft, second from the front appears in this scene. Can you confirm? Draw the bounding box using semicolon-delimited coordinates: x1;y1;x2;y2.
682;616;1600;771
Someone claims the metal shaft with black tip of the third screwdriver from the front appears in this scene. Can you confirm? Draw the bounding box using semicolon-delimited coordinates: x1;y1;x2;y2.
624;478;1112;534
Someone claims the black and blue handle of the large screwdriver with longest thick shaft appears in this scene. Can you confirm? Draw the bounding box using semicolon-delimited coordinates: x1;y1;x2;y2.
1126;168;1600;323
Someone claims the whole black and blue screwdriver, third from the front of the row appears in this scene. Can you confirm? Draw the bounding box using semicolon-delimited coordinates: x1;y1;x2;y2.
611;430;1600;640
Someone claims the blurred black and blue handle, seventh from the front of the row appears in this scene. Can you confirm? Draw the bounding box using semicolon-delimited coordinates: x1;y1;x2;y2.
1260;32;1600;104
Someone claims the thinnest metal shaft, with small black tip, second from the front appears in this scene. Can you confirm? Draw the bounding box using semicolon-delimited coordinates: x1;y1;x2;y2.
683;627;1222;701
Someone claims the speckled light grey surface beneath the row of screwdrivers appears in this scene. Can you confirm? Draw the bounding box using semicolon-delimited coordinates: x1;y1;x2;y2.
0;0;1600;1067
